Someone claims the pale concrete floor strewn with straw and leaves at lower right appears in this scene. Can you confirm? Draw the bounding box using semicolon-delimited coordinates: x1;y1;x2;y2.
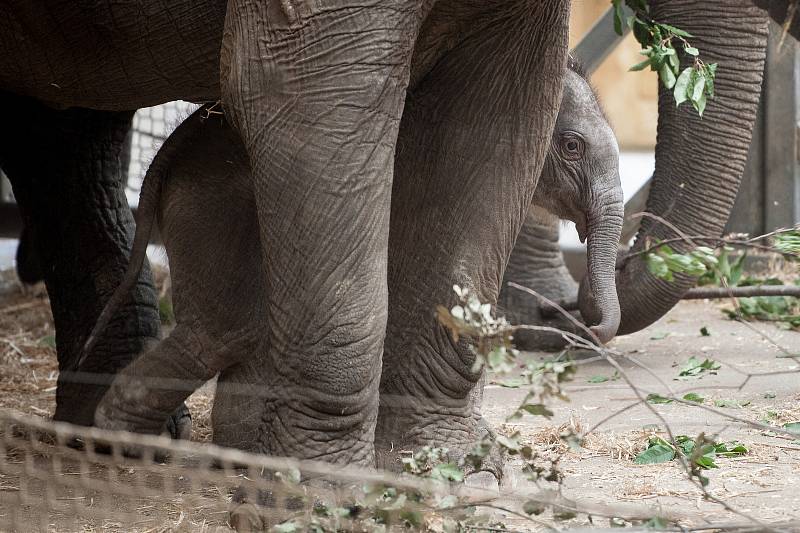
483;302;800;531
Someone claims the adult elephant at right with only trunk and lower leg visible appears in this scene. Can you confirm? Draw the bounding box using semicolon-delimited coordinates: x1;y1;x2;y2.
500;0;780;347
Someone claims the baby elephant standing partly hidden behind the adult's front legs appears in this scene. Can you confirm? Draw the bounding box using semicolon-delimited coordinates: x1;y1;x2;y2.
87;58;622;452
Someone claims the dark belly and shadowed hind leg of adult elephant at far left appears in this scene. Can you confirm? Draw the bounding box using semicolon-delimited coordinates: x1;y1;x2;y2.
0;0;226;436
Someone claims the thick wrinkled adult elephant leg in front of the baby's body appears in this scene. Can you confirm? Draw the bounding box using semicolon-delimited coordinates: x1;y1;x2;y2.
221;0;426;464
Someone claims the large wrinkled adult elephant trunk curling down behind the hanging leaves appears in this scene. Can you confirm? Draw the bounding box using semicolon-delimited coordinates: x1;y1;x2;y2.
581;0;767;334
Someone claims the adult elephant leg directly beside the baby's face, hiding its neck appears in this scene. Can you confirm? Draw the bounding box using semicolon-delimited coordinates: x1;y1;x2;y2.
375;1;569;474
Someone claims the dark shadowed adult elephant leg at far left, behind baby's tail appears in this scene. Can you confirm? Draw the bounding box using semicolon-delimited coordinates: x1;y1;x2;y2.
0;94;186;433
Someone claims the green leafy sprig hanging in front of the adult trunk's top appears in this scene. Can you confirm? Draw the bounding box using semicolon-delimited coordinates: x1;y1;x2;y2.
611;0;717;117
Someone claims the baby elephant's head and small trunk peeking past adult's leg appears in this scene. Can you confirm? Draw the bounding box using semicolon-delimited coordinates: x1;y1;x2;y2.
533;58;623;342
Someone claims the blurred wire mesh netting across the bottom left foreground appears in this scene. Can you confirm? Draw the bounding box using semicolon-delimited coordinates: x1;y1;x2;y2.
0;410;520;532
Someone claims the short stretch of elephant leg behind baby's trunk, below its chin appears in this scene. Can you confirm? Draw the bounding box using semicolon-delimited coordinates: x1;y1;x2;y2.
497;206;578;350
